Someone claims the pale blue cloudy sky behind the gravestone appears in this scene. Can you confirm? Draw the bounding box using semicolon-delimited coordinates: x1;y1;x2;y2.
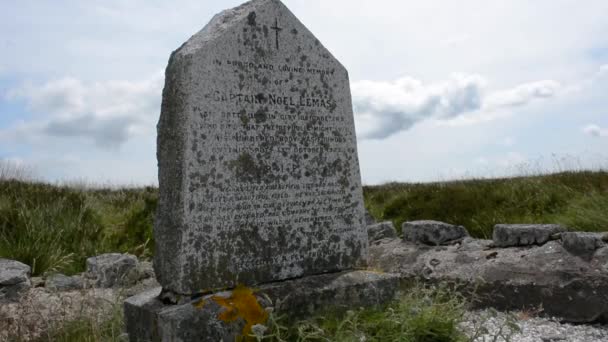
0;0;608;184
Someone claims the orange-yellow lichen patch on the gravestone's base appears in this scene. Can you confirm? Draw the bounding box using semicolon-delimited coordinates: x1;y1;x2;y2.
211;285;268;336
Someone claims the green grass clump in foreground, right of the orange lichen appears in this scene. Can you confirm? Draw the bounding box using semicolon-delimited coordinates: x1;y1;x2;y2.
259;285;468;342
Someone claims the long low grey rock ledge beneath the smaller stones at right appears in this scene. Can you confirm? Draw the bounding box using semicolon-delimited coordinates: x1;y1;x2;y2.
369;238;608;323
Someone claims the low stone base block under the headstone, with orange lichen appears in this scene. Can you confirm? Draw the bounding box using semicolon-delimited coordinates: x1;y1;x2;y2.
124;271;399;342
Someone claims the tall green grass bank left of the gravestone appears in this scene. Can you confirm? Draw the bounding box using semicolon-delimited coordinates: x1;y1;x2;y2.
0;180;157;275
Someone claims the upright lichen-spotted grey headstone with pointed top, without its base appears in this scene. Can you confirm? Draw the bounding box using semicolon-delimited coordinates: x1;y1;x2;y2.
154;0;367;294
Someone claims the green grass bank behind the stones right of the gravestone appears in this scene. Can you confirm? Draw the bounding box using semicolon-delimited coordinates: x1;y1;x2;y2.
363;171;608;238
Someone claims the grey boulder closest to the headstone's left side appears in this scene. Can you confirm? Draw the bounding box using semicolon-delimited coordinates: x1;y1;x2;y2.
86;253;137;288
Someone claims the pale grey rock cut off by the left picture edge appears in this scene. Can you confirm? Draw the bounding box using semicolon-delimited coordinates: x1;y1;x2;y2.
0;258;32;301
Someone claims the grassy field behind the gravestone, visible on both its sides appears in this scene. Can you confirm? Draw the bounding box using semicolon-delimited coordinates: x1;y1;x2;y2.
0;171;608;275
